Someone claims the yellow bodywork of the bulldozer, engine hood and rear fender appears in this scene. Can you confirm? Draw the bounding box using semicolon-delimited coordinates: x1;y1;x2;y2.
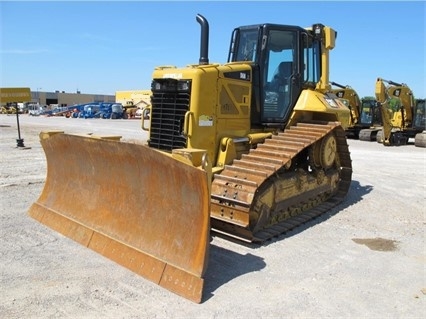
153;62;349;172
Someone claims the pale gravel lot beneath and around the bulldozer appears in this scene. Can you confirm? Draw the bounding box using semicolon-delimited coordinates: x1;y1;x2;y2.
0;115;426;318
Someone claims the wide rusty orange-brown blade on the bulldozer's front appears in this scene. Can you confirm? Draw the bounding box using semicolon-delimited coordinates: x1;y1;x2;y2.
29;132;210;303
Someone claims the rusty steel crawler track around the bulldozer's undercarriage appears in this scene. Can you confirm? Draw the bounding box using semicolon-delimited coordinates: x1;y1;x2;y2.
211;122;352;242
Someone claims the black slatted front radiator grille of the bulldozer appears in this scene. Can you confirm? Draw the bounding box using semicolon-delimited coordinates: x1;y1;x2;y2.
148;91;190;152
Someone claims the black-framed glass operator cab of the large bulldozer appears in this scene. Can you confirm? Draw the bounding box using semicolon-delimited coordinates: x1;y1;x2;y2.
228;24;323;126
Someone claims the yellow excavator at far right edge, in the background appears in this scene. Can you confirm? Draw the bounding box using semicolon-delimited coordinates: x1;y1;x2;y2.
375;78;425;146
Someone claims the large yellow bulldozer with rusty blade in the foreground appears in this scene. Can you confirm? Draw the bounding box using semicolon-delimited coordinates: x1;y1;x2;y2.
29;15;352;302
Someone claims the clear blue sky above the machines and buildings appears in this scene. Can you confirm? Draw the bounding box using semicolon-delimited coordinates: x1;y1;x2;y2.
0;0;426;98
